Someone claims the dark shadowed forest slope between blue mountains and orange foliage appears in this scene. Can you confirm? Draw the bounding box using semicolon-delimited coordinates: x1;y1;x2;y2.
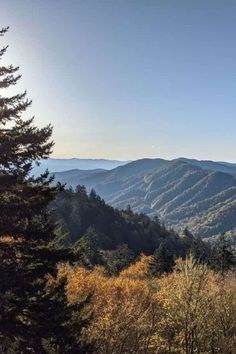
51;186;235;272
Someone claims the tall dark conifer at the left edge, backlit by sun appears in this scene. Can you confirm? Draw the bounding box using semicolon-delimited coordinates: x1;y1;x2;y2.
0;28;90;354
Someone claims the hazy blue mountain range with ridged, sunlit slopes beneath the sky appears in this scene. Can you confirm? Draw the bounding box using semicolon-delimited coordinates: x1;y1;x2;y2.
50;158;236;238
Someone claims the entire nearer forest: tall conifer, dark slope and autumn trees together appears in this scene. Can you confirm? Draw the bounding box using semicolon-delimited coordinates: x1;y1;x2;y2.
0;28;236;354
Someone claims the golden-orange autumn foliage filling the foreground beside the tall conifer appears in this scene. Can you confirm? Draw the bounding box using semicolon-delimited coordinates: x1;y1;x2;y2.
55;256;236;354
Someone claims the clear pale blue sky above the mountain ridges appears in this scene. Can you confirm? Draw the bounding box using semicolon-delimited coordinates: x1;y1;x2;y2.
0;0;236;162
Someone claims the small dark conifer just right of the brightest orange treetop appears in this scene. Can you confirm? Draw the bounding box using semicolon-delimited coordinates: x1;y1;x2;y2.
148;244;174;277
